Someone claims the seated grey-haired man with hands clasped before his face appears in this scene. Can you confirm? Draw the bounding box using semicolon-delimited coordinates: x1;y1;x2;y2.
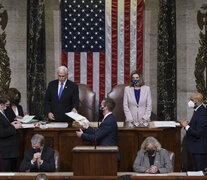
20;134;55;172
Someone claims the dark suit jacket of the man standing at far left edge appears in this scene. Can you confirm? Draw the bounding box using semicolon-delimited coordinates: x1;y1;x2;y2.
0;112;19;158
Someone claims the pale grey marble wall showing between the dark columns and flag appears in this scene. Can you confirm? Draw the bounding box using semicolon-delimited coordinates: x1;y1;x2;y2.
0;0;206;120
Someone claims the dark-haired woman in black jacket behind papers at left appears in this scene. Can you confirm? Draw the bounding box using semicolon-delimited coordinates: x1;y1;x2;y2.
5;88;28;122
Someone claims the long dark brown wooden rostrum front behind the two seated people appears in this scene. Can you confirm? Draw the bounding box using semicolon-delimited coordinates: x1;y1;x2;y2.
20;127;181;172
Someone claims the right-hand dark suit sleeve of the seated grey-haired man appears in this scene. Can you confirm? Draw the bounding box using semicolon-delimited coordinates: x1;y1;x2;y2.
40;150;55;172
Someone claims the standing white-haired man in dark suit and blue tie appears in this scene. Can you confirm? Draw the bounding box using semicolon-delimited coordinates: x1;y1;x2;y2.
45;66;79;122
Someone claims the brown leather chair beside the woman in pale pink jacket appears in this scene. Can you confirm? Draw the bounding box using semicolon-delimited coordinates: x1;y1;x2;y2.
107;84;127;122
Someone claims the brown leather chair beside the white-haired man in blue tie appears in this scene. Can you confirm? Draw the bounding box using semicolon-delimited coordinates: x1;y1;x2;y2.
78;84;96;122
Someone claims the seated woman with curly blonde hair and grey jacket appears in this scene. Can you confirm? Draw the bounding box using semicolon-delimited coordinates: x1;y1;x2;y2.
133;136;173;174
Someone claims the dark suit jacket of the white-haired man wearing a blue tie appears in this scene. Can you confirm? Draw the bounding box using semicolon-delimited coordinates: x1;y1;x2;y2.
45;80;79;121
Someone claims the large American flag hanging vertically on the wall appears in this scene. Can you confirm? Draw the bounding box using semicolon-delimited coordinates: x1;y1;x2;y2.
61;0;144;116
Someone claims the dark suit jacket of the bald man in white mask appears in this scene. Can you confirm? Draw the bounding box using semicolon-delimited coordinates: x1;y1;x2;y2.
186;105;207;153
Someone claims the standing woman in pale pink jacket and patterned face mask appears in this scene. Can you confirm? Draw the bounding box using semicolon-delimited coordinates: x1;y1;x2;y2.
123;70;152;127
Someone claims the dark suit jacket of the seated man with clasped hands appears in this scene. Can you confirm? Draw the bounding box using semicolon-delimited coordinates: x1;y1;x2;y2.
20;146;55;172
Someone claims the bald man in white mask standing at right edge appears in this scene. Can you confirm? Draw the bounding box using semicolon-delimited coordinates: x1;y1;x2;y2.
181;93;207;171
